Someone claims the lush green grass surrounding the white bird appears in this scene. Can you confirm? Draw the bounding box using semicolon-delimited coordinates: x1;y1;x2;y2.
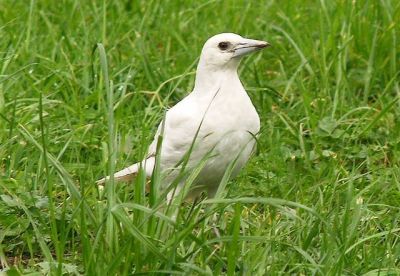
0;0;400;275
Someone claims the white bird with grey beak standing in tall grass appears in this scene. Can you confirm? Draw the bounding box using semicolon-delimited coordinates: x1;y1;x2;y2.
97;33;270;200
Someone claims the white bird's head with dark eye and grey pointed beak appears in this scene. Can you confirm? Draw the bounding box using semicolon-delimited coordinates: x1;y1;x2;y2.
199;33;270;71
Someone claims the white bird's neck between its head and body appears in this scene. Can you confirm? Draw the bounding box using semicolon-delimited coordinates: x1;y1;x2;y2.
194;63;240;94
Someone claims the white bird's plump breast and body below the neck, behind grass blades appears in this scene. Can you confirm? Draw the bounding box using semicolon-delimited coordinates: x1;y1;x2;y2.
161;77;260;196
